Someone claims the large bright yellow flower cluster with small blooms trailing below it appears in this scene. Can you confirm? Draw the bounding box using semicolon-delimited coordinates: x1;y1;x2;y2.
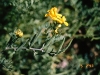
45;7;68;33
